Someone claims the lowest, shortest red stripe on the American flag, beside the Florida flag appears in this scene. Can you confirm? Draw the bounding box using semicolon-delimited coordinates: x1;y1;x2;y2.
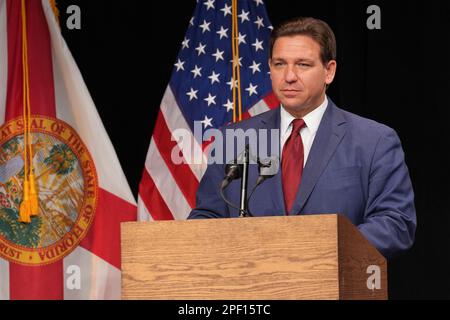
139;169;174;220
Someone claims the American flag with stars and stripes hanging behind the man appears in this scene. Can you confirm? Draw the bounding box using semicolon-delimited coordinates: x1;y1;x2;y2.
138;0;278;221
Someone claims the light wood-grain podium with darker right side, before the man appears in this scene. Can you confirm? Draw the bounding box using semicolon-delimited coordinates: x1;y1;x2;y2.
122;214;387;300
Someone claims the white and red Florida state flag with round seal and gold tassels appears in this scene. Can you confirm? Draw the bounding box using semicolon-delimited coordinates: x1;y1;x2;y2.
0;0;136;299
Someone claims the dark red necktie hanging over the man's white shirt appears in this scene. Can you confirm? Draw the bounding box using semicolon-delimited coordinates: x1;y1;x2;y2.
281;119;305;214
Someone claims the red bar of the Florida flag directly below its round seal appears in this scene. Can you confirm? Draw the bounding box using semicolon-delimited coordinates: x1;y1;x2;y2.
9;260;64;300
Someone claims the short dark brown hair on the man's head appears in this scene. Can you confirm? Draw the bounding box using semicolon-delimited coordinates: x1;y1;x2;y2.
269;17;336;65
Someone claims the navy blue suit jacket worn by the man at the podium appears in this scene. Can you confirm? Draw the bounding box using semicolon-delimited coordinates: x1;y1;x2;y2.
189;99;416;258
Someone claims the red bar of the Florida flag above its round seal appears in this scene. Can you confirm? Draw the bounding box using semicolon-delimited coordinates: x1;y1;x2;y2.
5;0;56;121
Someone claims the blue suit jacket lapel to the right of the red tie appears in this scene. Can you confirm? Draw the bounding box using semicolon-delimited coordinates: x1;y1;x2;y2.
290;99;346;214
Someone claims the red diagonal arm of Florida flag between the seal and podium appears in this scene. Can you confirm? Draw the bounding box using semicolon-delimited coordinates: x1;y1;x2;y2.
80;188;136;269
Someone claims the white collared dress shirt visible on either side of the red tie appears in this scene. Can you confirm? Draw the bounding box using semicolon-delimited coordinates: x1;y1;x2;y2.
280;96;328;167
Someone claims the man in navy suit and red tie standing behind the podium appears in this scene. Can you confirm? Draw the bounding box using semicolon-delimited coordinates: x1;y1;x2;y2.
189;18;416;258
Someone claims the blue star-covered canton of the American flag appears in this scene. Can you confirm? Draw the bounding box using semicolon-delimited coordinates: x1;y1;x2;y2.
170;0;272;130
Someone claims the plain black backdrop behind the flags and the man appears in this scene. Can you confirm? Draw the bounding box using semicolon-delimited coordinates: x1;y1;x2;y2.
57;0;450;299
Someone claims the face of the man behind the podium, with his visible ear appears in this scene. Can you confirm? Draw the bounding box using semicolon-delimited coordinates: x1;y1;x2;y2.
269;35;336;117
